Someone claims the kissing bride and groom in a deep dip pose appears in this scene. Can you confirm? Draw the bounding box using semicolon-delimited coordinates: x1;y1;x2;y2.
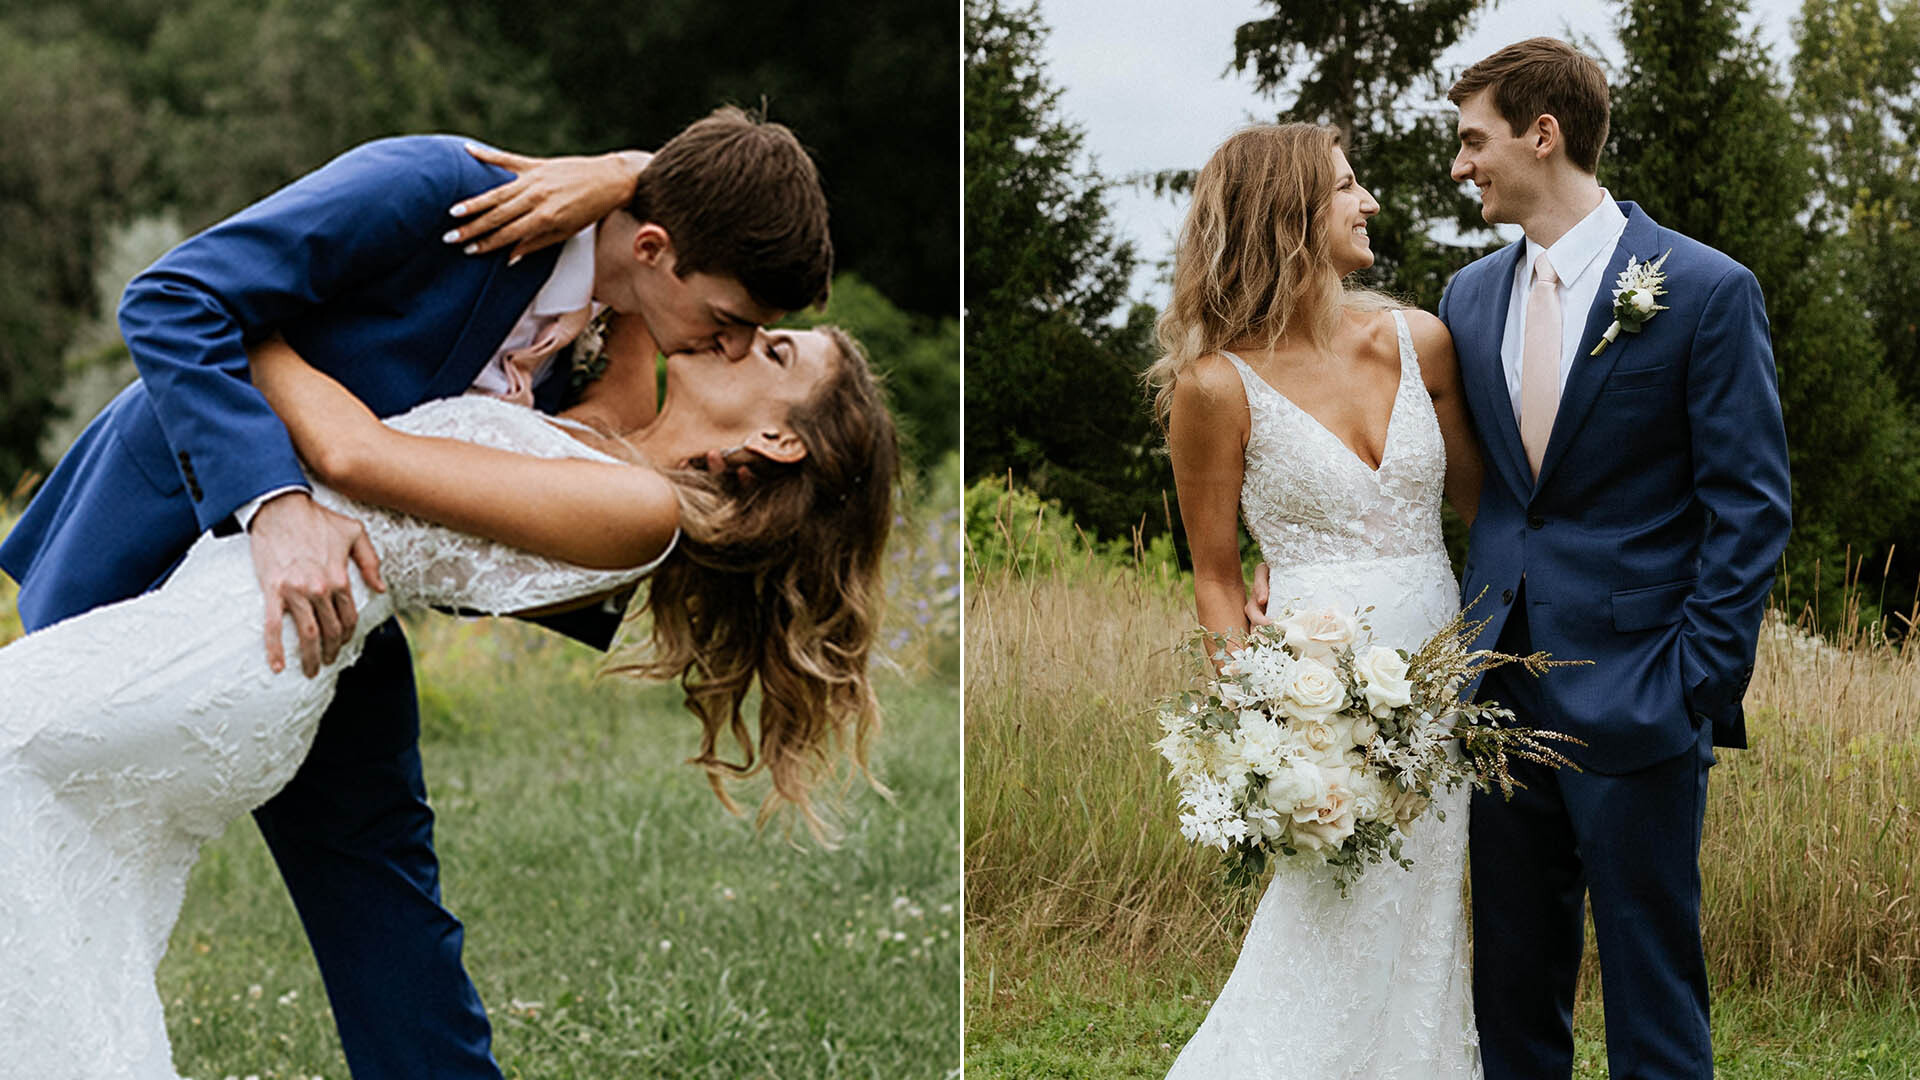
0;108;899;1080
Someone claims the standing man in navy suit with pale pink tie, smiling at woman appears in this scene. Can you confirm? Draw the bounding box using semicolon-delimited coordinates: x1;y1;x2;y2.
1440;38;1789;1080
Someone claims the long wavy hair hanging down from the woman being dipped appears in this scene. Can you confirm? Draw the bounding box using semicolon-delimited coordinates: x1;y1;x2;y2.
609;327;900;844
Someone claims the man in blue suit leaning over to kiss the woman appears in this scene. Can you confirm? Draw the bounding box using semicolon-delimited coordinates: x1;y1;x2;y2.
0;110;831;1080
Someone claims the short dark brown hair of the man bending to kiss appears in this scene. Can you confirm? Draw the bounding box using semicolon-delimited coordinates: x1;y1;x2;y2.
628;106;833;311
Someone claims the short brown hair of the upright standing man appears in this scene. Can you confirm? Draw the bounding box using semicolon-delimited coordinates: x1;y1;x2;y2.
1446;38;1609;173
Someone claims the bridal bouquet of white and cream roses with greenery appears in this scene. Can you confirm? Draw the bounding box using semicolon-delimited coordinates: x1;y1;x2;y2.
1154;595;1572;896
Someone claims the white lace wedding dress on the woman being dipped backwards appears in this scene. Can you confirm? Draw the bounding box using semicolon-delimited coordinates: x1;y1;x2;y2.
0;396;664;1080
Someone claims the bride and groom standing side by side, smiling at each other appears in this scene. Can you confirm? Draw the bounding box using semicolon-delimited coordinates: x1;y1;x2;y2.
1150;38;1789;1080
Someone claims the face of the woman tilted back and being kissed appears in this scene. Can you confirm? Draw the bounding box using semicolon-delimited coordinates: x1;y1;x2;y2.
662;331;839;461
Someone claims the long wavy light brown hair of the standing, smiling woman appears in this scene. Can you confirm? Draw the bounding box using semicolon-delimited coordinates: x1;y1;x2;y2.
1146;123;1400;429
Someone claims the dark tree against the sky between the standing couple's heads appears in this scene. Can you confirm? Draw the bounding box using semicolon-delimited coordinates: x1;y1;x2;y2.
1233;0;1486;311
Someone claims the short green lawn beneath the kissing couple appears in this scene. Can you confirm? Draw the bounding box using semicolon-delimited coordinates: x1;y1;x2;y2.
159;619;960;1080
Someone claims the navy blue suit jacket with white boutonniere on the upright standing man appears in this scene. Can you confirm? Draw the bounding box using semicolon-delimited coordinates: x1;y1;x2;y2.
1440;202;1791;773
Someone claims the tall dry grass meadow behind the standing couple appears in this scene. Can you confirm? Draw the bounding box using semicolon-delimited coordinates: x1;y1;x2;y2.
966;549;1920;1080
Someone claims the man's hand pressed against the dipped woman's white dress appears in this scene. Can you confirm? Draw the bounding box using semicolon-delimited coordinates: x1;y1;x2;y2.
248;492;386;678
